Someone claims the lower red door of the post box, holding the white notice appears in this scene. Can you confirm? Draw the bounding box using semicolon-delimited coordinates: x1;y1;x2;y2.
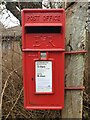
24;52;64;109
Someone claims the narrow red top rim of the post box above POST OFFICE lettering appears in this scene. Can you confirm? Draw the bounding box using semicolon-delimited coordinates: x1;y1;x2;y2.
22;8;65;13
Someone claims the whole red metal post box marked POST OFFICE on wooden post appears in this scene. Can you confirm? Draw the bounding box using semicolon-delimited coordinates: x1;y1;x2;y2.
22;9;65;109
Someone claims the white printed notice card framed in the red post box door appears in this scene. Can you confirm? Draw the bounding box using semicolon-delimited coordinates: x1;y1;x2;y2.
35;61;52;92
